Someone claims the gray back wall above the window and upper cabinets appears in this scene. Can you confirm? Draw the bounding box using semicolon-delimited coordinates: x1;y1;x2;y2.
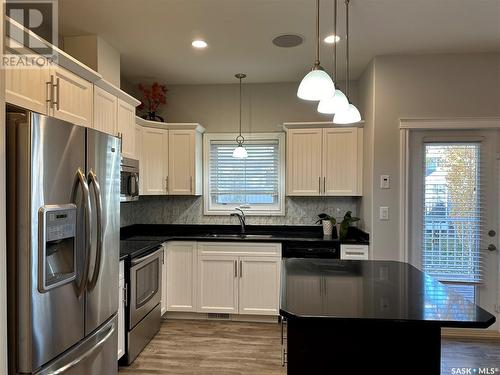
124;79;357;132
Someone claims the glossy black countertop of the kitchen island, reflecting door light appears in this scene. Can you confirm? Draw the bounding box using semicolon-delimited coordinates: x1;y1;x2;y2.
280;258;495;328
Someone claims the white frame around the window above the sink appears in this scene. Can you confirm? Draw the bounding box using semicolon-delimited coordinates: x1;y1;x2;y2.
203;132;286;216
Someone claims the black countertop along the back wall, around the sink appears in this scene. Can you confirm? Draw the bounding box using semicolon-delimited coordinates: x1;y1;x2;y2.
120;224;369;260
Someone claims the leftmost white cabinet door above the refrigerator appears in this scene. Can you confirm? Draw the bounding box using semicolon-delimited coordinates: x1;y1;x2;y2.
5;67;51;114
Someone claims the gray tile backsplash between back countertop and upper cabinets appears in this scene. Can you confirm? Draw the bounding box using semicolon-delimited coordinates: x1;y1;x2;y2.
120;196;360;227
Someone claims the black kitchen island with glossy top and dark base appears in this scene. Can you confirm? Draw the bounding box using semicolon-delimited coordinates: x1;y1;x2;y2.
280;258;495;375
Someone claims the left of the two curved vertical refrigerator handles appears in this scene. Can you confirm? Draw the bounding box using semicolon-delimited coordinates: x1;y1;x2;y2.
71;168;92;297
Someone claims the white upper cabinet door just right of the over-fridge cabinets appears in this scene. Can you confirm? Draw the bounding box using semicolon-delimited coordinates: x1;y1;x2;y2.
93;86;118;135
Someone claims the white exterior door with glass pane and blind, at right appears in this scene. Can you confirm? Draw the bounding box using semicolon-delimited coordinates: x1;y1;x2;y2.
409;130;500;330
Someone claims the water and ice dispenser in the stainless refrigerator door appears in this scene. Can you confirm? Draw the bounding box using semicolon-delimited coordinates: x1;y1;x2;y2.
38;204;77;293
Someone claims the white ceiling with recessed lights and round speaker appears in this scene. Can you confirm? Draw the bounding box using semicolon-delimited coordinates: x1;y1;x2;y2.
59;0;500;84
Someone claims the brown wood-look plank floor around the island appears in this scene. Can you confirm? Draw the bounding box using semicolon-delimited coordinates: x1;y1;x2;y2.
119;320;500;375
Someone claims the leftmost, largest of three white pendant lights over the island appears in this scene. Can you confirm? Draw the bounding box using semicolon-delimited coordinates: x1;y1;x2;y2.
297;0;335;100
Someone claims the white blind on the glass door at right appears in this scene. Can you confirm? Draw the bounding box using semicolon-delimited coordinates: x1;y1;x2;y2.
422;142;482;286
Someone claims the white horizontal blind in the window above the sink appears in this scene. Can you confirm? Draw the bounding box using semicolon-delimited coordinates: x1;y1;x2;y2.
208;139;282;213
